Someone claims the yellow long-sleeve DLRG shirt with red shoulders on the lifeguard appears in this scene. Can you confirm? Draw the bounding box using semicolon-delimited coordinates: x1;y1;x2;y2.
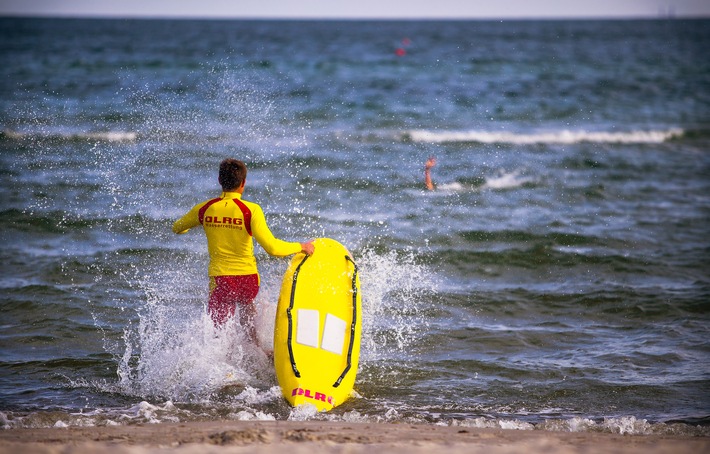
173;192;301;276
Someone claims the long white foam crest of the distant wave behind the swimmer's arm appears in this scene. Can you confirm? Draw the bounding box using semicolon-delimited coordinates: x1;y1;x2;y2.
404;128;683;145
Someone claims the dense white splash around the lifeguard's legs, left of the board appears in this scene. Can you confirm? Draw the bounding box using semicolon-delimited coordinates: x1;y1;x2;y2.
119;303;270;402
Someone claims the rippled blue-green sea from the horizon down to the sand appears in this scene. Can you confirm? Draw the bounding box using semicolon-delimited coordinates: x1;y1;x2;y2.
0;18;710;436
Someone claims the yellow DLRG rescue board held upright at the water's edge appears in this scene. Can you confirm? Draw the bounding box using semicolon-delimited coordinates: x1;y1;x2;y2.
274;238;362;411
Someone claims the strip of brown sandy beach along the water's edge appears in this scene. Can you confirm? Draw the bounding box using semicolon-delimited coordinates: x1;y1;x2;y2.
0;421;710;454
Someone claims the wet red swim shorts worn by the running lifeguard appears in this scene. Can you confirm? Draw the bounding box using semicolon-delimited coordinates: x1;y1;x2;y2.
207;274;259;326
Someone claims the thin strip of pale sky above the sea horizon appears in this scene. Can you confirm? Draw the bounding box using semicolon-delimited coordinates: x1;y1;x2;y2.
0;0;710;19
